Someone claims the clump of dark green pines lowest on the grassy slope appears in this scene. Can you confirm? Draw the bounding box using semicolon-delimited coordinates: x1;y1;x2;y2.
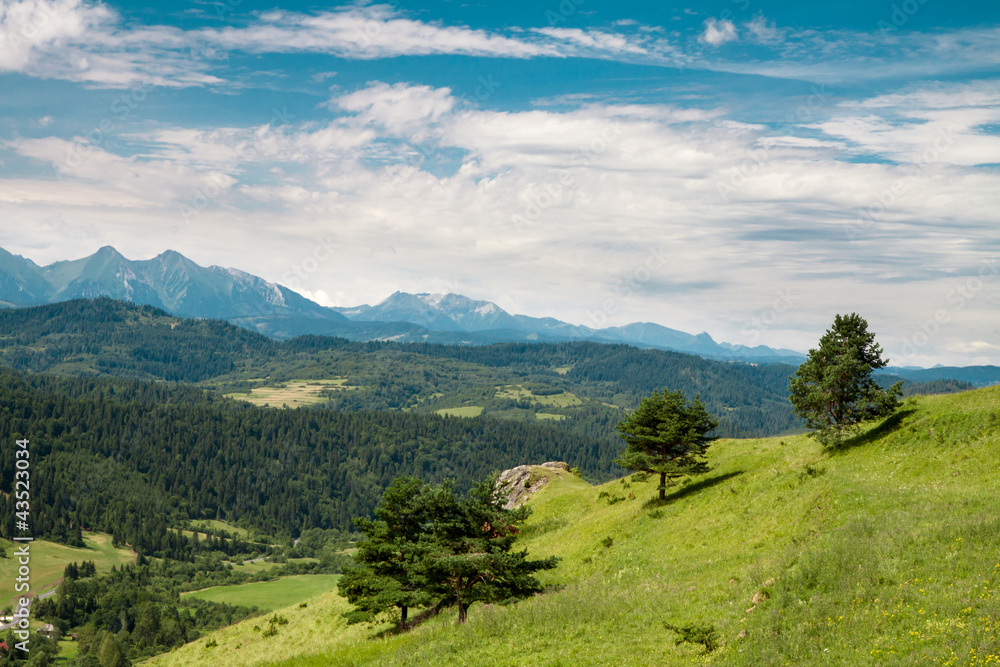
338;477;558;627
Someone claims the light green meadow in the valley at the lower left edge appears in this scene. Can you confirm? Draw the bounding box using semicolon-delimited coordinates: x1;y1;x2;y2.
0;533;135;604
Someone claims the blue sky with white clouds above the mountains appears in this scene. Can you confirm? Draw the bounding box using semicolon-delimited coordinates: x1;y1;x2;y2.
0;0;1000;366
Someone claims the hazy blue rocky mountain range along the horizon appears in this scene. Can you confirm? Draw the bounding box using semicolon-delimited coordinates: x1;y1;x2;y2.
0;246;1000;386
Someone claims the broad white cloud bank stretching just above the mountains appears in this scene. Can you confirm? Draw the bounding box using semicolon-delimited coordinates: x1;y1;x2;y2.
0;76;1000;362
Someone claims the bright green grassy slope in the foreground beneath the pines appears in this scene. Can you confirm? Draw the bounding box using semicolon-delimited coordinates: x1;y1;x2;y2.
146;388;1000;666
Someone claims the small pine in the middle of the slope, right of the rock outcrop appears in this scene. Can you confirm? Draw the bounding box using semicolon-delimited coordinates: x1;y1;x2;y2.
615;391;719;500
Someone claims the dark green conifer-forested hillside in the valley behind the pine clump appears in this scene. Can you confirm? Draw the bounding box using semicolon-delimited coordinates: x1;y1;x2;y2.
0;371;616;557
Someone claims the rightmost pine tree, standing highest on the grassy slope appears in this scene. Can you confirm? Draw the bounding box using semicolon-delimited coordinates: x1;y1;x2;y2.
788;313;902;446
